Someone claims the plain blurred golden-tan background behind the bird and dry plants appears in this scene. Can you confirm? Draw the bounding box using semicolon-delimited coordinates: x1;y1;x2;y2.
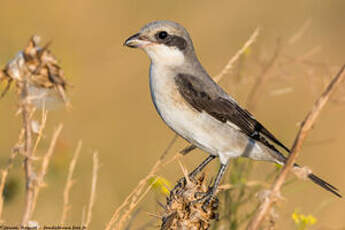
0;0;345;229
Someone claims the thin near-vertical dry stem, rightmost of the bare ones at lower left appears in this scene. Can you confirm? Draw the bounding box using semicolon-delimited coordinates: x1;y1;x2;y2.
84;152;99;228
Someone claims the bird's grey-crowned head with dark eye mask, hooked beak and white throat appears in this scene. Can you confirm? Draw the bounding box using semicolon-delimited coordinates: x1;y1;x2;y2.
124;21;194;66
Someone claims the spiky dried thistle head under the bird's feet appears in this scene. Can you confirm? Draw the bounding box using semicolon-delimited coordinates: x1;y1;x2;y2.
161;174;218;230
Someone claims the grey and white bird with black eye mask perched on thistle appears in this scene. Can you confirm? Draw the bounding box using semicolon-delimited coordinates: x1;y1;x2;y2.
124;20;341;204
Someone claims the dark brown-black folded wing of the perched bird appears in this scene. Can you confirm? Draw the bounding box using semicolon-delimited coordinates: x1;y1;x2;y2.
175;74;290;152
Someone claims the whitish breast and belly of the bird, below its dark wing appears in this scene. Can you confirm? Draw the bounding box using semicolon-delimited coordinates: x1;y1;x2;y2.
150;64;228;154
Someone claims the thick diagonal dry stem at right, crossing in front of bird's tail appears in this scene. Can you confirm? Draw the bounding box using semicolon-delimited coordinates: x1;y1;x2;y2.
247;65;345;230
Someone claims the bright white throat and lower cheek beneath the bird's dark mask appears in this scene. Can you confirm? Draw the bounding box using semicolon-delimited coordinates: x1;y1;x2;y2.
144;44;185;67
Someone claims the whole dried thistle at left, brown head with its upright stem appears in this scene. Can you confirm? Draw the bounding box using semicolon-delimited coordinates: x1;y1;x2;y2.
0;36;67;225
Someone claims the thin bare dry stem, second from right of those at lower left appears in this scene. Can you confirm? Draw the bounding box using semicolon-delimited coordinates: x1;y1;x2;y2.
60;140;82;225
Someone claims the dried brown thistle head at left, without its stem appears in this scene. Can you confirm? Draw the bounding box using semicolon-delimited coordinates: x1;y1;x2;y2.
0;35;68;107
